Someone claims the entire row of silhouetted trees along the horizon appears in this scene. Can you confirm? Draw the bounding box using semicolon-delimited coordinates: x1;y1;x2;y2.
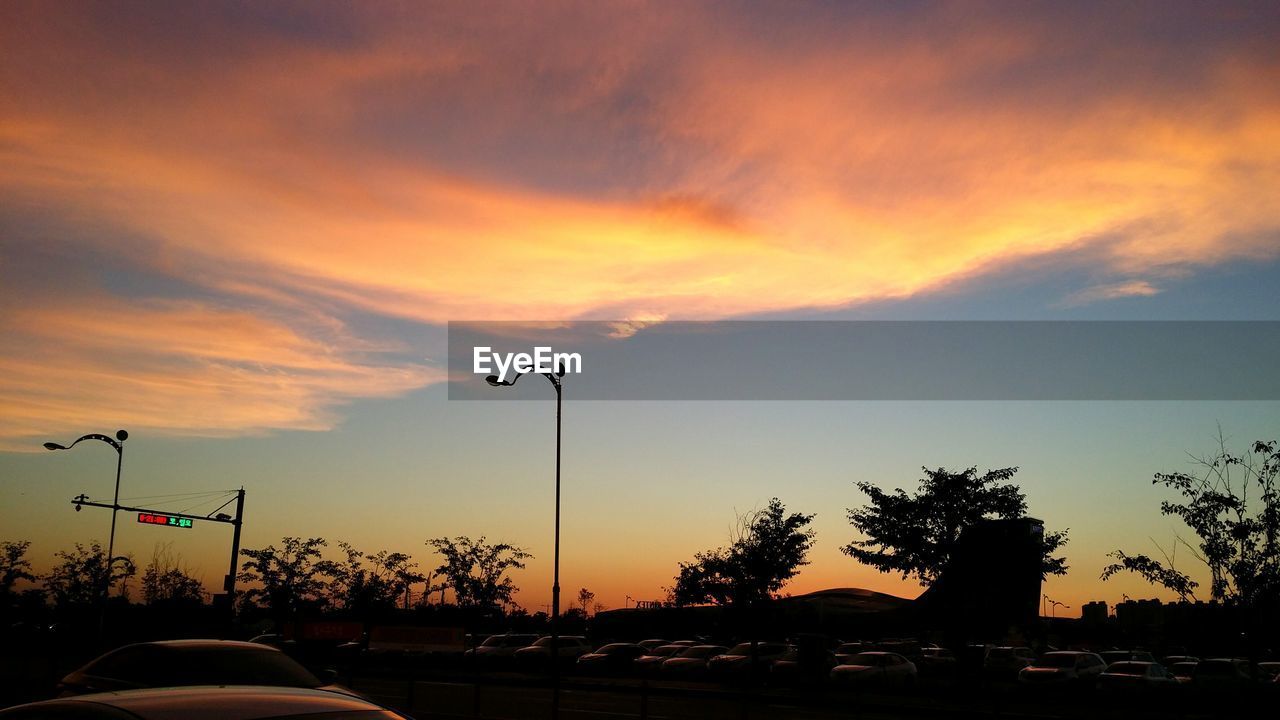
0;427;1280;620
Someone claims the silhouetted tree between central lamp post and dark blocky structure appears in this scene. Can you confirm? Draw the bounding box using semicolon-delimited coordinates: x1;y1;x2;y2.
669;497;815;605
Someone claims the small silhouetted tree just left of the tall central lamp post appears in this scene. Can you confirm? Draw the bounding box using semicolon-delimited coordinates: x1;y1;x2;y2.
426;536;532;609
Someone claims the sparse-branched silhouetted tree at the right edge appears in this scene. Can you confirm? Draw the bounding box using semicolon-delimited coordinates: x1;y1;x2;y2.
1102;429;1280;606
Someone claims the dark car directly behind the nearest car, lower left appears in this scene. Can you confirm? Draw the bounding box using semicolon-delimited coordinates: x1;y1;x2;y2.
58;639;356;697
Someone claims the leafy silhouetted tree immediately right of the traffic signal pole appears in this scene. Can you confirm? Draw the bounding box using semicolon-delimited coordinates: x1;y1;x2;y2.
237;537;335;620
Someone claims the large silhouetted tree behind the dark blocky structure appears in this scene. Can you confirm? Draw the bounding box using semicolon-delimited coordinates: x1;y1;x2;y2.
841;468;1066;585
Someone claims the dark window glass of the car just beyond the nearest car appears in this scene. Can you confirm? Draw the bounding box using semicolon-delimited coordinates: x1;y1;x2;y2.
161;647;324;688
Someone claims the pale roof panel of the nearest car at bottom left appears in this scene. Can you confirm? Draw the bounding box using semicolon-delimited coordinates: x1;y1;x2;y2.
1;685;385;720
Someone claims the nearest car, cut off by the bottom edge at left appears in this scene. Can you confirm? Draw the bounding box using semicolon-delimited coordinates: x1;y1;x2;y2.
0;685;408;720
